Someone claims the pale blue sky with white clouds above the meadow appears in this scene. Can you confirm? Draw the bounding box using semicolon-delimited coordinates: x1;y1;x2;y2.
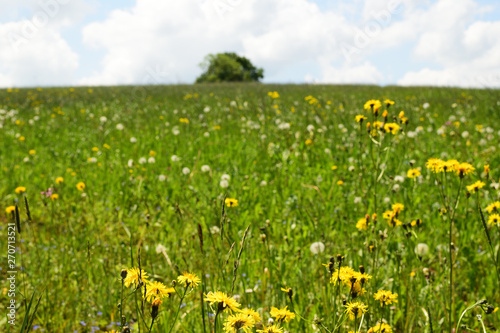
0;0;500;88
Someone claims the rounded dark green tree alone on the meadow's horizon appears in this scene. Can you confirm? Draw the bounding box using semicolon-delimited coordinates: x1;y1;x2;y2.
196;52;264;83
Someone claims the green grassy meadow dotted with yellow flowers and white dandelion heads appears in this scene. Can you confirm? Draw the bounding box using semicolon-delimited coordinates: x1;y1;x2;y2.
0;85;500;333
